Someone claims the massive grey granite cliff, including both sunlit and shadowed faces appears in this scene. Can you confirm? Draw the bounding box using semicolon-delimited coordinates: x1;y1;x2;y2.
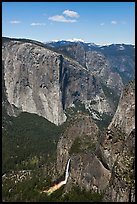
2;39;119;125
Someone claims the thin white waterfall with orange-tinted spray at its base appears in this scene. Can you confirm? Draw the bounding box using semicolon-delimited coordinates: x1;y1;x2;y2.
42;159;70;195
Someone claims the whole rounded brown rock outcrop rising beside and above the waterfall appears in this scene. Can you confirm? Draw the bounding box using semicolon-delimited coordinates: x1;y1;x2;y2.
57;114;111;191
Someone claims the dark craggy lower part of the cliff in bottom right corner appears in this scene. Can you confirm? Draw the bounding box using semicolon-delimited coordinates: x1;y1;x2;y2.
104;130;135;202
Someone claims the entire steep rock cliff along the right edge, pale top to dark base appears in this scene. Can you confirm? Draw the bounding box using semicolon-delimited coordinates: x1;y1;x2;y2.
102;81;135;202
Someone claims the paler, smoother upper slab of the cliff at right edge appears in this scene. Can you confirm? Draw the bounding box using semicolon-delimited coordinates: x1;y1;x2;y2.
103;81;135;168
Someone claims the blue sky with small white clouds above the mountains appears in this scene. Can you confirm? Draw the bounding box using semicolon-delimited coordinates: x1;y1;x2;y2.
2;2;135;44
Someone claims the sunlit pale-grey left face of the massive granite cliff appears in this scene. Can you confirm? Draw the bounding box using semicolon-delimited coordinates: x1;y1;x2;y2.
3;41;66;125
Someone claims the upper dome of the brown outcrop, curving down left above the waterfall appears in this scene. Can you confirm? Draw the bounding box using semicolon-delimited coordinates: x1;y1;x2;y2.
57;113;99;173
